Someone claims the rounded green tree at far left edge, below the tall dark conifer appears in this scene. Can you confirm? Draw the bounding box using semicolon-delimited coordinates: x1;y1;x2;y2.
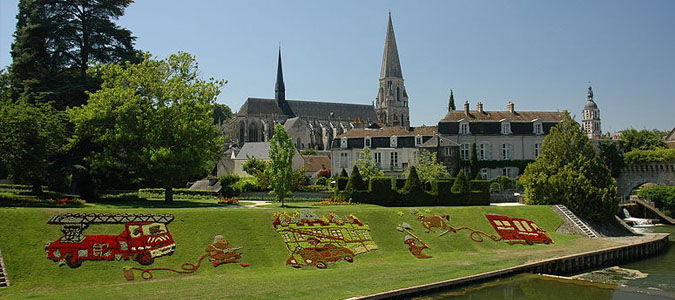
0;102;66;194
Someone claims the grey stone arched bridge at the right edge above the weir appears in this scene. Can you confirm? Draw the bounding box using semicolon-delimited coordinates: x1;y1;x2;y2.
616;162;675;197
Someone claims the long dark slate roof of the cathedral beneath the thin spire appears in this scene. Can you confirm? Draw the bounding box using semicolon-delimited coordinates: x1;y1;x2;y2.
238;98;377;121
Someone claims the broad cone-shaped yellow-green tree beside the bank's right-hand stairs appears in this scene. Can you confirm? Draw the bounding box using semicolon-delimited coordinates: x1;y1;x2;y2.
521;112;618;221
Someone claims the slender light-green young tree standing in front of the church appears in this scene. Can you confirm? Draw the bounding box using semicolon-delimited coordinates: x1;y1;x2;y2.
265;123;295;207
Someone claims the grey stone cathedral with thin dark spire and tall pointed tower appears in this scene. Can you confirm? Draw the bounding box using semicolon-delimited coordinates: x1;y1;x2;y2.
223;13;410;150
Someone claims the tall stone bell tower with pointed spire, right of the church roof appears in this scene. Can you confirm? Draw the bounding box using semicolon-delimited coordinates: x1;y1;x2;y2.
375;13;410;127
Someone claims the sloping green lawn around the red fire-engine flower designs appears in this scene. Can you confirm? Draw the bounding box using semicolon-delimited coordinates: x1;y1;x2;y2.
0;203;624;299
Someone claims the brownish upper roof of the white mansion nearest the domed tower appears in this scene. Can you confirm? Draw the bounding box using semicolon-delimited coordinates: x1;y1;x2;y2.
441;110;562;122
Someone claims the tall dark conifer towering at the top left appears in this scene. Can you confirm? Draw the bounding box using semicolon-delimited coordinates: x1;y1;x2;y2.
10;0;138;109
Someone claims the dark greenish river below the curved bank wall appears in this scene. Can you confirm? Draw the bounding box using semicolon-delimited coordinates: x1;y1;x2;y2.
415;226;675;300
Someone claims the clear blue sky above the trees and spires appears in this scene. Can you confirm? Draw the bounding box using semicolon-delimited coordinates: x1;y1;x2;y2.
0;0;675;132
